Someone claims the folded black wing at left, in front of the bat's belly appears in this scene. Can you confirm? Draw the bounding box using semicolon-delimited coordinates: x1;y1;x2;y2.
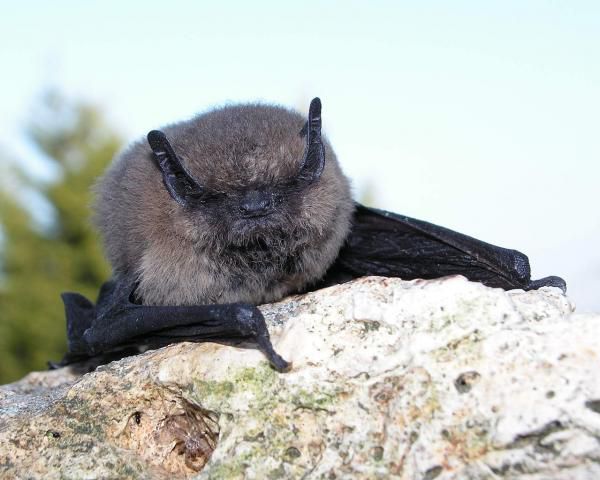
54;278;289;371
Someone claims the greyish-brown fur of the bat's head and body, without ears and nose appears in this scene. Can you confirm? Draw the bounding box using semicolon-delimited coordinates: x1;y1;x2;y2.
95;104;353;305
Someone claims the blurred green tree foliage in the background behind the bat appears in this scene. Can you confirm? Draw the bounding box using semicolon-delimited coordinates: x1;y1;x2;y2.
0;93;121;383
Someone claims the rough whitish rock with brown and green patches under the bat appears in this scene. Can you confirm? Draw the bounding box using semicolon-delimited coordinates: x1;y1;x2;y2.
0;277;600;480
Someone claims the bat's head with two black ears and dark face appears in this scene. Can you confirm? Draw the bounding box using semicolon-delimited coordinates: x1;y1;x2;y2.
148;98;347;248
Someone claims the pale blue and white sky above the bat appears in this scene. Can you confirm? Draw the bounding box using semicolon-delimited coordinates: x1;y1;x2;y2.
0;0;600;310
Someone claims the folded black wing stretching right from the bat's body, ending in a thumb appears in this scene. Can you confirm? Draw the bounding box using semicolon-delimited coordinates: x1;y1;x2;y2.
318;204;566;291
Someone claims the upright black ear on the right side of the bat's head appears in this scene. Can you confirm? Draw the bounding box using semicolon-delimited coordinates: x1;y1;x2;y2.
298;97;325;183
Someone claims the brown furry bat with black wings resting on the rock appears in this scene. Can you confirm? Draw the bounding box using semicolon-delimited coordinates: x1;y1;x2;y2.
54;98;566;371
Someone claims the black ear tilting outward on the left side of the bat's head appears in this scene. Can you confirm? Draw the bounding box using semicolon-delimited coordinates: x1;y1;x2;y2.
148;130;204;207
